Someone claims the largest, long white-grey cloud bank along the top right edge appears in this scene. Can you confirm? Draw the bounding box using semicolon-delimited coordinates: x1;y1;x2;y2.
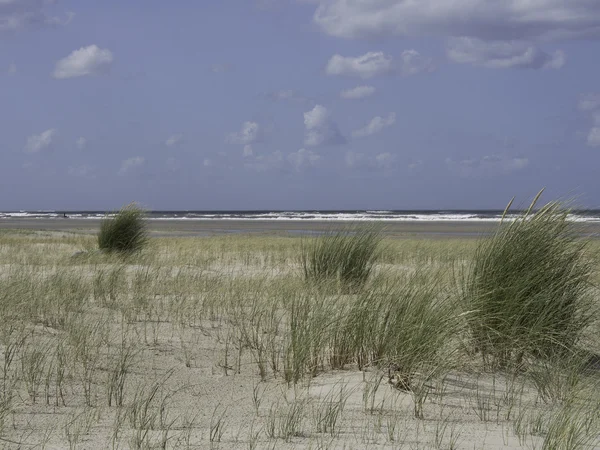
314;0;600;41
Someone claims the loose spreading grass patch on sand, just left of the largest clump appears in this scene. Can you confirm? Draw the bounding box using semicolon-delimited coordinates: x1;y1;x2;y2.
283;270;464;391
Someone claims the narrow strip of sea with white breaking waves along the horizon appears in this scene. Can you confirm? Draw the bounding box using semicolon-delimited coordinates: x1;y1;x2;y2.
0;210;600;222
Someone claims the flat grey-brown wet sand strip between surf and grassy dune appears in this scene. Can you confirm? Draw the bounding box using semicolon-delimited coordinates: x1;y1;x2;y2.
0;218;600;238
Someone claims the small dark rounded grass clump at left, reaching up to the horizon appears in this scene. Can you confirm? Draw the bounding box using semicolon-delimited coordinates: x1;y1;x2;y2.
98;203;148;253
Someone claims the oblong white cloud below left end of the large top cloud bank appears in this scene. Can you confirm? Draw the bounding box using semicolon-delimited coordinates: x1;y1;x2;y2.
325;52;392;79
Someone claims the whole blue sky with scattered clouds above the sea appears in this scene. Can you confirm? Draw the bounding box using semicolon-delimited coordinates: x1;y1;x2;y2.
0;0;600;210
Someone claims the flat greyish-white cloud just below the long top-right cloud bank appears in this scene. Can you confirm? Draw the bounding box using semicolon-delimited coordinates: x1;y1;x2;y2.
446;37;566;69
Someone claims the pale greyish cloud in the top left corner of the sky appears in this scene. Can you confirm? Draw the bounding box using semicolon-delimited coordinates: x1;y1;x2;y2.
0;0;75;32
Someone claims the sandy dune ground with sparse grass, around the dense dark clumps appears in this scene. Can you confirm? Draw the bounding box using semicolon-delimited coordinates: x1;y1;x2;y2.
0;217;600;449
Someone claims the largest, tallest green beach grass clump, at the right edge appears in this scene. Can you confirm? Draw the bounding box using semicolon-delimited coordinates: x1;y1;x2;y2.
462;192;593;367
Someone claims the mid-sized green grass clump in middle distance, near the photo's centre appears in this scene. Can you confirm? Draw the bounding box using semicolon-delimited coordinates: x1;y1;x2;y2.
301;224;382;288
